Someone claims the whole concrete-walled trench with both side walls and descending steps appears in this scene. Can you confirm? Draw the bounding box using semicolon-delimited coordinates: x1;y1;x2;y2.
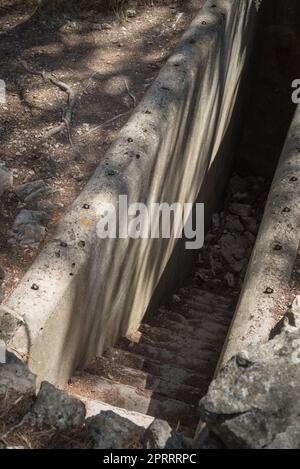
0;0;300;446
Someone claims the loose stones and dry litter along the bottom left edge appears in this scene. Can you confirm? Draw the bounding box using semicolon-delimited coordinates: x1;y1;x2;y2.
0;353;185;449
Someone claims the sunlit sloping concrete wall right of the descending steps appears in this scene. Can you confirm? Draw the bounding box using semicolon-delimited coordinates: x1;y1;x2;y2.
220;106;300;364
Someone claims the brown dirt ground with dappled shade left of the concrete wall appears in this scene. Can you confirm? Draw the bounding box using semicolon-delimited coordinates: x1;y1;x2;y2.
0;0;203;296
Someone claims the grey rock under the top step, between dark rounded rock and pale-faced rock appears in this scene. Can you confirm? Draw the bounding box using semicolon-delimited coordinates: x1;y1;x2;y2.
86;411;145;449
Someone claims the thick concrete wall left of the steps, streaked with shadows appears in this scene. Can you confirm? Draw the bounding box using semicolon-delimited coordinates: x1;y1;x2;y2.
0;0;255;384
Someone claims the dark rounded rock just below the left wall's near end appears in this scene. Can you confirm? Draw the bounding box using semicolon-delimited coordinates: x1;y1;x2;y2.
28;382;86;430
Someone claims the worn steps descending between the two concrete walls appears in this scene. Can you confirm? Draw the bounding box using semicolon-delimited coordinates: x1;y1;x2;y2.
68;270;237;437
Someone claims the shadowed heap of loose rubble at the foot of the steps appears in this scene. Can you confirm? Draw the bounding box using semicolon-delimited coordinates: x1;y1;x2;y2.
198;175;268;289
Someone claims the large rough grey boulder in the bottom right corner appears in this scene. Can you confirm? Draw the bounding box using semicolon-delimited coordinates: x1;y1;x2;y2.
200;309;300;449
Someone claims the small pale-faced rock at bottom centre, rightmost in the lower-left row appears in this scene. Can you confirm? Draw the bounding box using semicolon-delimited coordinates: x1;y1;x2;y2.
142;419;184;449
